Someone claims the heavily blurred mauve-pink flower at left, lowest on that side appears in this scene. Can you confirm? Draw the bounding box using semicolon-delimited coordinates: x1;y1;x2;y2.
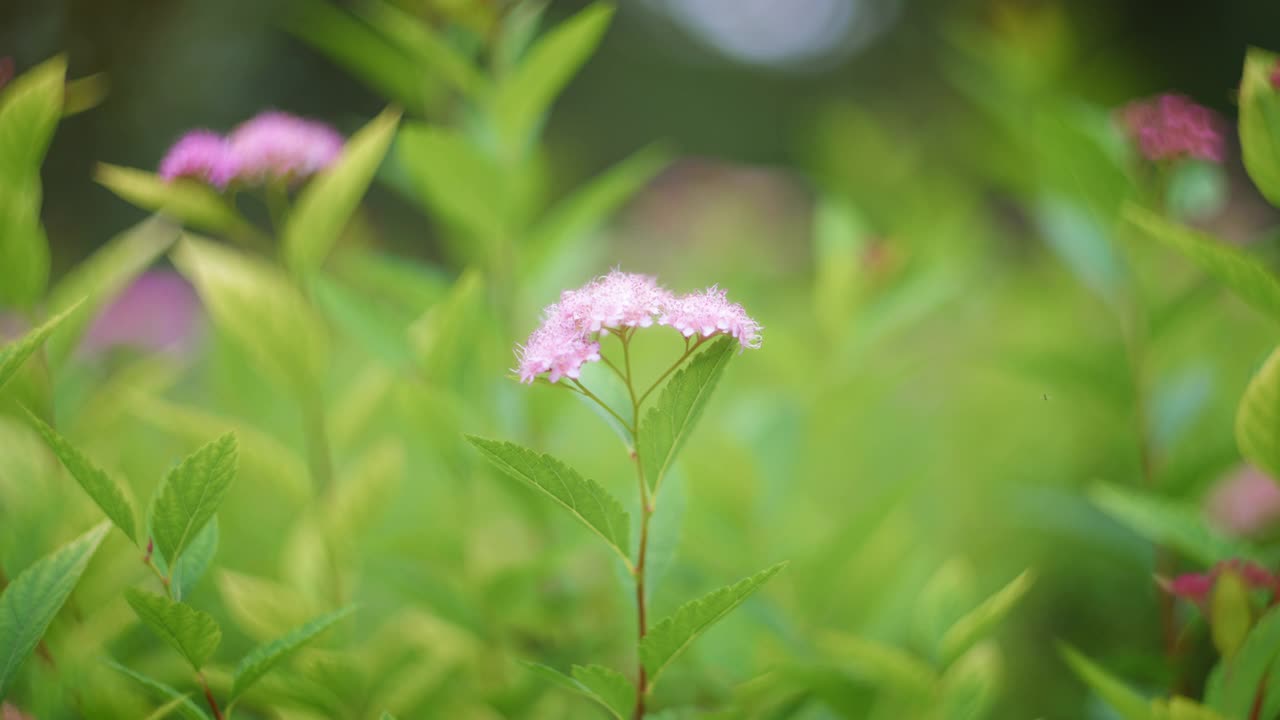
81;270;200;356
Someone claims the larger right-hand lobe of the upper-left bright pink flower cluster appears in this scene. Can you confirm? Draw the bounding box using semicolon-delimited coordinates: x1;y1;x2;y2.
228;110;343;183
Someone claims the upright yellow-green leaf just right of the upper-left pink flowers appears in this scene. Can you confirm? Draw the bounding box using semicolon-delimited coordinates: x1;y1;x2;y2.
280;110;399;274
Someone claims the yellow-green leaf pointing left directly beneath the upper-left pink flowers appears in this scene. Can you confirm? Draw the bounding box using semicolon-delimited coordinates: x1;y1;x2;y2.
93;163;257;236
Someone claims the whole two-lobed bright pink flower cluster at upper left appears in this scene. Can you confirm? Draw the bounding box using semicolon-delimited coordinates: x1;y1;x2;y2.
160;110;343;190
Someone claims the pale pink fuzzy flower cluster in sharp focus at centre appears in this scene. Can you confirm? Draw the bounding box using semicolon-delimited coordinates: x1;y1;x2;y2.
516;270;760;383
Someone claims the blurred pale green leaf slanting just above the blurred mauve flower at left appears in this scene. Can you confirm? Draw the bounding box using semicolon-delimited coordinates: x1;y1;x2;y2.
45;218;178;369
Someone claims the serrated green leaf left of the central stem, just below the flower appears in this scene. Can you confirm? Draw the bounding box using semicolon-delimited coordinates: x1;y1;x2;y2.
466;436;631;568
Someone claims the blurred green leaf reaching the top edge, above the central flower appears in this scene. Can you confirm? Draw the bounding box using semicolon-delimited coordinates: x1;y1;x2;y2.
492;3;613;154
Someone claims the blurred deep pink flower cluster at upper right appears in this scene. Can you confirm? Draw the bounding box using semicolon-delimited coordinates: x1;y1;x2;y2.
1120;94;1226;163
